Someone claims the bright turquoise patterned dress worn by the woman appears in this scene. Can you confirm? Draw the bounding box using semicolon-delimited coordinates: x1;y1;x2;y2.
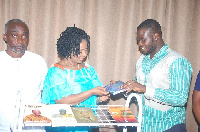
42;63;102;132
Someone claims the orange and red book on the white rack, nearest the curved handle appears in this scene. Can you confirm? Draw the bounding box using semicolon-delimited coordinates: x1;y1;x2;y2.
108;106;138;123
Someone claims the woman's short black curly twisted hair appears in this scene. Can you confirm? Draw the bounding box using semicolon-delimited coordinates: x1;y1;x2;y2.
57;27;90;58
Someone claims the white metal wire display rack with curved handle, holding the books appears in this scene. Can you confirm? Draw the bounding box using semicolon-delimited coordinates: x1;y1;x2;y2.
16;93;142;132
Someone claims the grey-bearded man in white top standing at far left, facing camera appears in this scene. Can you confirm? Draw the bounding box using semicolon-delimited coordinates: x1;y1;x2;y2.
0;19;48;132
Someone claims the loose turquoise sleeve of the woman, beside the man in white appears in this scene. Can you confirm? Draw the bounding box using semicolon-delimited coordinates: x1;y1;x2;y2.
42;67;71;104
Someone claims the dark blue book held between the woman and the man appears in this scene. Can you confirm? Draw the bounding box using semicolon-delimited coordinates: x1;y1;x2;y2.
105;81;125;95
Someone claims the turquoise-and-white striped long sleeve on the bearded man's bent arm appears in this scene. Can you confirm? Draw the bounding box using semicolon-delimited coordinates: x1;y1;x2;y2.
150;58;193;106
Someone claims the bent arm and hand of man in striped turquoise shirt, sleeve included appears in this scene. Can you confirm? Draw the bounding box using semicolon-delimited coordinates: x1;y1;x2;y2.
119;58;193;106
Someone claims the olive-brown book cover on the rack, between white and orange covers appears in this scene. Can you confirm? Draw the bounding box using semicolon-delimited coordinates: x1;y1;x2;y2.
72;107;98;123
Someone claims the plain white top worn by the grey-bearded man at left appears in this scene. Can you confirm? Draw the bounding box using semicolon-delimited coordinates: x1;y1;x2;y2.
0;51;48;131
